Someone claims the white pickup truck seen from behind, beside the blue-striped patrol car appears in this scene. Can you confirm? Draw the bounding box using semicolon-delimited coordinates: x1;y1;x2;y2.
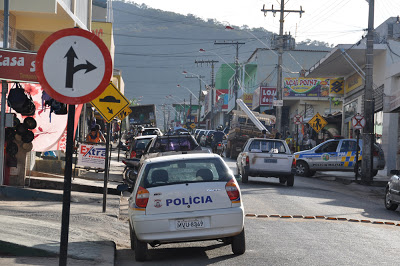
236;138;296;187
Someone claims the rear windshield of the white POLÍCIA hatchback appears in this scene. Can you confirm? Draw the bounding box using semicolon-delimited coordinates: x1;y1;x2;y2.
140;158;232;188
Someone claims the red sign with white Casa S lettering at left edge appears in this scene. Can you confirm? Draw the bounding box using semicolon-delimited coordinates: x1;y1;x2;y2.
0;49;38;83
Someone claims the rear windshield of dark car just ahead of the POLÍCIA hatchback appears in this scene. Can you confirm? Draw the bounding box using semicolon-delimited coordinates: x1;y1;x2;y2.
153;136;198;152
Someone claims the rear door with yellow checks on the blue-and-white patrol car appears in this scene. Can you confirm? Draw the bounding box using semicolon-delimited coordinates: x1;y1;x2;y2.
337;139;361;170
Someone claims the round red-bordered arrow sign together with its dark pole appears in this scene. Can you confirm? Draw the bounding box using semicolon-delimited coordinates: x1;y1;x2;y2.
36;28;112;265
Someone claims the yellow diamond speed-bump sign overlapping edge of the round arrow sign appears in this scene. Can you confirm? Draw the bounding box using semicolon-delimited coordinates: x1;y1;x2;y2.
90;82;129;122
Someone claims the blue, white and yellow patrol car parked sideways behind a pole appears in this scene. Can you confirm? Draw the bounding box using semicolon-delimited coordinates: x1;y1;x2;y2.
295;139;385;176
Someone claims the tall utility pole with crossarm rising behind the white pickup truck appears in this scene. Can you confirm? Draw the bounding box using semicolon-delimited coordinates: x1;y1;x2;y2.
261;0;304;133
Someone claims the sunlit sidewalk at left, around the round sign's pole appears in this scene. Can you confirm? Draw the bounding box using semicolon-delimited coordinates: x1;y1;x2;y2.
0;151;128;265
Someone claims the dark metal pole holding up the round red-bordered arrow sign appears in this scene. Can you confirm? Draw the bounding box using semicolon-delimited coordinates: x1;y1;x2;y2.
59;104;75;266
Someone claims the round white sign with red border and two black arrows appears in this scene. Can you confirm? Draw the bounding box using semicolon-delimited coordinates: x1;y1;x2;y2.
36;28;112;104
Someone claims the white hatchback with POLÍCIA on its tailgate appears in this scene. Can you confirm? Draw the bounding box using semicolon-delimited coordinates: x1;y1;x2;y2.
129;154;246;261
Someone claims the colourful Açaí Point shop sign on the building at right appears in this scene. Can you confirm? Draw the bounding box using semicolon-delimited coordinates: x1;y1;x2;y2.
283;78;329;97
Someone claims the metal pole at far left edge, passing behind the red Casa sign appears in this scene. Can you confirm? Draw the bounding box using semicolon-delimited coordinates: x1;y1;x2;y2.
0;0;10;186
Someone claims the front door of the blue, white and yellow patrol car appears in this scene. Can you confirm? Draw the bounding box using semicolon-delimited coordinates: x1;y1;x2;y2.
311;140;339;170
